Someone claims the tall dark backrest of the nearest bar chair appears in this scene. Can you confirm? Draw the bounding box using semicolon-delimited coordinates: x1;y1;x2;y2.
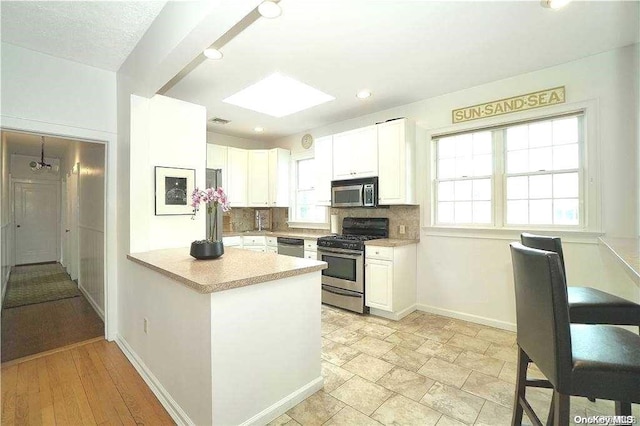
511;243;573;390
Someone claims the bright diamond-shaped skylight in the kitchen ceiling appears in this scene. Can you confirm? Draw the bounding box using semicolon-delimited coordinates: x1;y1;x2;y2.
224;73;335;117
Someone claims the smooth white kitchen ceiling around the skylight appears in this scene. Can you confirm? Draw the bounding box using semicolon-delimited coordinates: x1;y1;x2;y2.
166;0;640;140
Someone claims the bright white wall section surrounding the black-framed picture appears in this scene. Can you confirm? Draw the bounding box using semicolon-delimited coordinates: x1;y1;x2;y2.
130;95;207;253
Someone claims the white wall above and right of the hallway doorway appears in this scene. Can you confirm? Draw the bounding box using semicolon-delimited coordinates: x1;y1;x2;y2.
0;43;117;339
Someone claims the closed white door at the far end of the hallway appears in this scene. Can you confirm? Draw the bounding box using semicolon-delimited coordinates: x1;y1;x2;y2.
14;182;60;265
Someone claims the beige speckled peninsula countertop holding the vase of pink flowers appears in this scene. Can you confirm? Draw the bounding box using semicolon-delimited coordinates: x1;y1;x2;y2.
127;247;327;293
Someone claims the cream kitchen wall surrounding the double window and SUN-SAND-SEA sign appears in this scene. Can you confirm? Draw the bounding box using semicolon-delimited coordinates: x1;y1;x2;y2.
271;45;640;328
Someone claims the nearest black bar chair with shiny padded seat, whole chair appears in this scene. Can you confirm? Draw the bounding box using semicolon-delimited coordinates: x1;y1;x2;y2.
511;243;640;426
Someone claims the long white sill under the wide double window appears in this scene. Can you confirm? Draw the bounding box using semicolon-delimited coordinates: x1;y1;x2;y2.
422;226;605;244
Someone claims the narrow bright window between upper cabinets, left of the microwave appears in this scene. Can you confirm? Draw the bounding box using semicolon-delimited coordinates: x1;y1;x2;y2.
289;154;329;228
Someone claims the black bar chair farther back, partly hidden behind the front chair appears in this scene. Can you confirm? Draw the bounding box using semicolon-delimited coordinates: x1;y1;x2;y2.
520;232;640;327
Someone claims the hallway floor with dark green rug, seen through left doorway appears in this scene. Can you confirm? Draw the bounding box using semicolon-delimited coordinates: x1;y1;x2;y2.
1;264;104;363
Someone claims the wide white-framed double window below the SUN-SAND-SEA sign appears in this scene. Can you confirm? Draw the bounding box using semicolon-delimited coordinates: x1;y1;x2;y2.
433;111;585;229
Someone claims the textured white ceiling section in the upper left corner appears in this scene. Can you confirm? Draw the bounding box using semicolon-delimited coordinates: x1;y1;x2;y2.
0;1;166;71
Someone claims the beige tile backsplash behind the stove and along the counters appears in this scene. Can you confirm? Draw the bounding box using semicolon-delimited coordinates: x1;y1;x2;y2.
225;206;420;240
